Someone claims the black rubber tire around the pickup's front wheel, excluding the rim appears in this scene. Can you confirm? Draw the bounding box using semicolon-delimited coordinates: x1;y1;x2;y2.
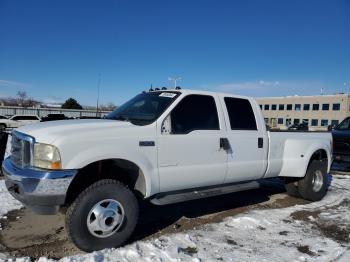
66;179;139;252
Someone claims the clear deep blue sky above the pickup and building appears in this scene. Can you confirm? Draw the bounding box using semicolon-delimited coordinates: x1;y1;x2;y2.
0;0;350;105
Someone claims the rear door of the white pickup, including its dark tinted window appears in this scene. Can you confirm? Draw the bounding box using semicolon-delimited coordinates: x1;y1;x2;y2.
220;95;267;183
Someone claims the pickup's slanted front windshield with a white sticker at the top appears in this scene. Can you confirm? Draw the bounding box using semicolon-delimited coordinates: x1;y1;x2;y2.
106;91;180;125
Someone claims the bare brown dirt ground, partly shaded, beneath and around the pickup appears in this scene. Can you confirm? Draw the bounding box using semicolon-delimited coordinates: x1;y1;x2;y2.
0;174;348;259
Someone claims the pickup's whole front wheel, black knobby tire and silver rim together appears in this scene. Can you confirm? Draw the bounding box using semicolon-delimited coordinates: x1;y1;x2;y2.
66;179;139;252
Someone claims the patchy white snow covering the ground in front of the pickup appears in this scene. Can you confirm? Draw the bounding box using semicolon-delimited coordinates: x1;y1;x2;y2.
0;176;350;262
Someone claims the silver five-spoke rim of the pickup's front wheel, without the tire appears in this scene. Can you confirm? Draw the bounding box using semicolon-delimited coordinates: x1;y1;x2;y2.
87;199;125;238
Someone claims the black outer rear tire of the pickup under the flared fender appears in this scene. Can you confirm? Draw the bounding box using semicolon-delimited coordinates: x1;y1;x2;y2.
298;160;328;201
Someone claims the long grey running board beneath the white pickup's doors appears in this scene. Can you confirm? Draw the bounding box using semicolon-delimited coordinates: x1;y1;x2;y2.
150;181;259;205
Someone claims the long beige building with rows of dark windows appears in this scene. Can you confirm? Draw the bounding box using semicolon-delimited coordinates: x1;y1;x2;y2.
256;94;350;130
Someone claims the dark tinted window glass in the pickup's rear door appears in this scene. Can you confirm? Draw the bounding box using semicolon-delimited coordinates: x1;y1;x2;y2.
224;97;257;130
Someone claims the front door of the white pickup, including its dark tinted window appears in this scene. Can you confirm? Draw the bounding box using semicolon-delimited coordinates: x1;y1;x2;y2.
158;95;227;192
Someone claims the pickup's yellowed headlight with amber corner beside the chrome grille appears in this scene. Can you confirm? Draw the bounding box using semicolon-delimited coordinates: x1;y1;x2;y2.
33;143;62;169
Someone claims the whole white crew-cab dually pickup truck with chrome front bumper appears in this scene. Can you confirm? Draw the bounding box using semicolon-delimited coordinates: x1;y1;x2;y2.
2;89;332;251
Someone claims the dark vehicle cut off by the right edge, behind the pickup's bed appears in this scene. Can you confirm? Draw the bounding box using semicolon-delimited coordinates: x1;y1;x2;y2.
332;117;350;171
